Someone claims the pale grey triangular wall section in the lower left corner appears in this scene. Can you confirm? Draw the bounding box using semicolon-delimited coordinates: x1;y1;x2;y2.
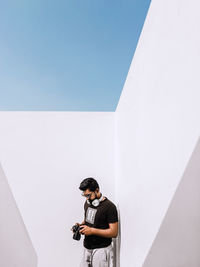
0;165;37;267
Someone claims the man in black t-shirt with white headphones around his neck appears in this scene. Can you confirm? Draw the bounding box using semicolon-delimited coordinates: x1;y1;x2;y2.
79;178;118;267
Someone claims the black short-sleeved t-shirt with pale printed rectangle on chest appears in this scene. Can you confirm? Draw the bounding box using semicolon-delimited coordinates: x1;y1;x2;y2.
84;198;118;249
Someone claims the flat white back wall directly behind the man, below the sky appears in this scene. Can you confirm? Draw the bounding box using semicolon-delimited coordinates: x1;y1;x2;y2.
0;112;114;267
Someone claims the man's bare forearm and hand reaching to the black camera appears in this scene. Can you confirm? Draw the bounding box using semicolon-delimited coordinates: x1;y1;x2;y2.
80;222;118;238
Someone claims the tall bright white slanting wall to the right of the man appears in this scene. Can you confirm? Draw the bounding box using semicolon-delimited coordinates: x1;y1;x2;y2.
115;0;200;267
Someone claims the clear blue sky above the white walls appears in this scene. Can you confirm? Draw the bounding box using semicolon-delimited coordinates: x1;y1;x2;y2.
0;0;150;111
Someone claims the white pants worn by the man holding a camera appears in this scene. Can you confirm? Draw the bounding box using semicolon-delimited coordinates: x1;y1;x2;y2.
80;245;114;267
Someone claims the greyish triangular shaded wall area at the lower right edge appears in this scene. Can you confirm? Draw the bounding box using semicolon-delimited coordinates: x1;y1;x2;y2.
143;140;200;267
